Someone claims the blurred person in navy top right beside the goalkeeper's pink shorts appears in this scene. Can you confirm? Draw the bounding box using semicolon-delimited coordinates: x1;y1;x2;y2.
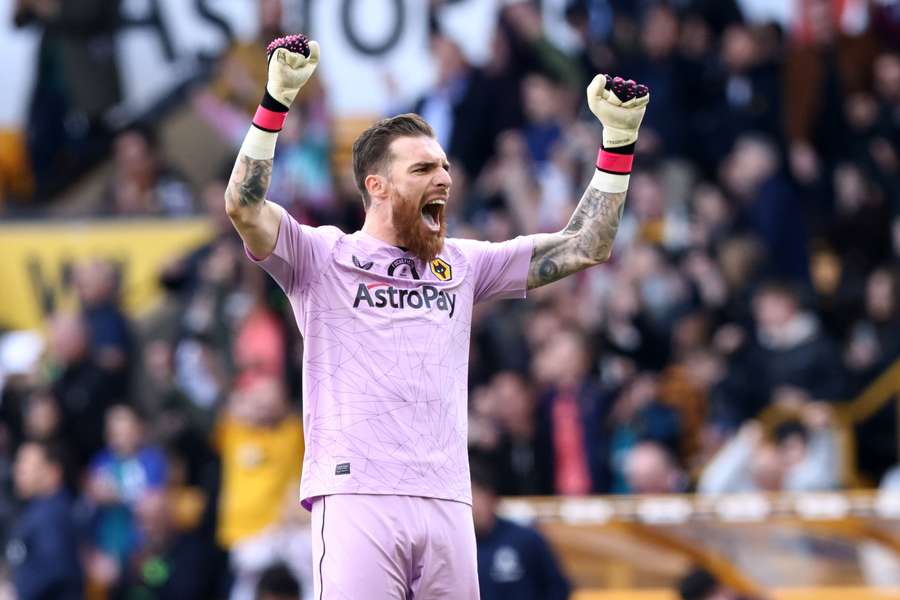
472;462;570;600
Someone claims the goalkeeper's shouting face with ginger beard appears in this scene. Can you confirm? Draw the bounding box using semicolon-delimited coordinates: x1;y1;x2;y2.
387;135;453;261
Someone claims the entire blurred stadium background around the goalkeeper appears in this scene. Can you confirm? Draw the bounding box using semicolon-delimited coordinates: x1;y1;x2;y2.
0;0;900;600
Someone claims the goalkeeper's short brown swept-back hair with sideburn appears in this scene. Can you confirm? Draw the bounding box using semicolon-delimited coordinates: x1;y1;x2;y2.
353;113;434;210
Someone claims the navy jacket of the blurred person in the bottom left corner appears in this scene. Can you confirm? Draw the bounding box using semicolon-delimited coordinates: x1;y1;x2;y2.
6;492;84;600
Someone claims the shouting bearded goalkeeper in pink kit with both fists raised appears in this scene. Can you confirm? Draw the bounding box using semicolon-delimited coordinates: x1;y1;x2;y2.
225;36;649;600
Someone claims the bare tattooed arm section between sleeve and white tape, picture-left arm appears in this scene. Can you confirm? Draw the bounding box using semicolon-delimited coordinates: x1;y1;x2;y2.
225;152;282;259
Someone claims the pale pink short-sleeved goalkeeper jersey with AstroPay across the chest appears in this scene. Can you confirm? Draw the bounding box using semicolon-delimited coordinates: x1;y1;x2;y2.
251;213;532;508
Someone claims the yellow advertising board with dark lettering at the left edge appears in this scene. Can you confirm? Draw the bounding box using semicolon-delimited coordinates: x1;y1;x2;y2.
0;219;213;329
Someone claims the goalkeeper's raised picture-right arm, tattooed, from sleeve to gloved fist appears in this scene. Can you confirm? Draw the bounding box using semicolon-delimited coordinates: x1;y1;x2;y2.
528;75;650;289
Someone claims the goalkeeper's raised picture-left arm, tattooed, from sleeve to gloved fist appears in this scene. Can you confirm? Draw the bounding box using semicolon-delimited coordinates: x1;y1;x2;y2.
225;36;319;258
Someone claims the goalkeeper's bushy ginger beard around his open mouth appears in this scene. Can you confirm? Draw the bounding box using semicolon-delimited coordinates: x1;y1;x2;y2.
391;185;447;262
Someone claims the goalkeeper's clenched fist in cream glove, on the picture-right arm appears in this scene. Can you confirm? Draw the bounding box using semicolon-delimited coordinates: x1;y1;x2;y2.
587;75;650;148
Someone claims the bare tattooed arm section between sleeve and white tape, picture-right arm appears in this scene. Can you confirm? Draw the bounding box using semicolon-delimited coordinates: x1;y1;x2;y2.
528;187;625;289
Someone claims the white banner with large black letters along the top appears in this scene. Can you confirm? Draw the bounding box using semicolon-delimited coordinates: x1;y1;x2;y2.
0;0;580;128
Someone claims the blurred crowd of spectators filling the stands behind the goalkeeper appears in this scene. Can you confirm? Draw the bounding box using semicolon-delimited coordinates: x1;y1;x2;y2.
0;0;900;598
